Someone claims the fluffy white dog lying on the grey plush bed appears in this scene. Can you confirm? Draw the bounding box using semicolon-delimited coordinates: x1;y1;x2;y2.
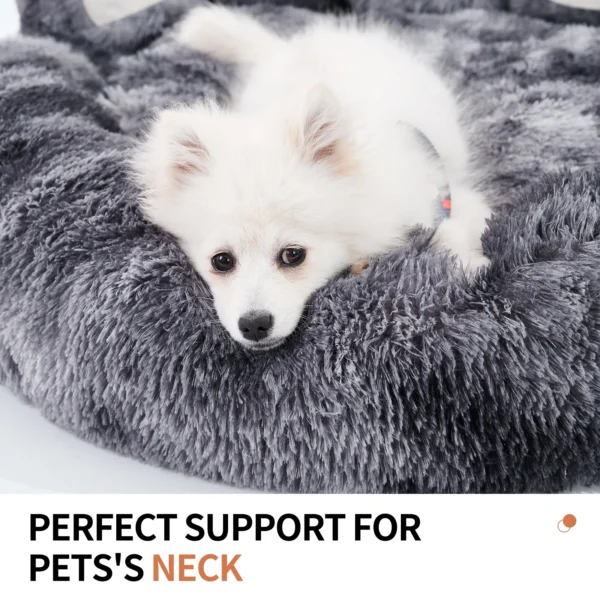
134;7;490;349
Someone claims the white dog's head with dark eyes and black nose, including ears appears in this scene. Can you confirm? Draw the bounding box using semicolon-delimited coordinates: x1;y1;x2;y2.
134;86;357;349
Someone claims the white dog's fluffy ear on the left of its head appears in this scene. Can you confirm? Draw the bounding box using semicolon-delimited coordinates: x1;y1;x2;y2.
131;108;210;226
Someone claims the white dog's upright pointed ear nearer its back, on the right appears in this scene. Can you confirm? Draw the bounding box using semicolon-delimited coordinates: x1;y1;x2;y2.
297;84;349;171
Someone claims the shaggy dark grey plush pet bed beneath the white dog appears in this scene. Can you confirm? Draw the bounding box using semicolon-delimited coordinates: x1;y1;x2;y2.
0;0;600;492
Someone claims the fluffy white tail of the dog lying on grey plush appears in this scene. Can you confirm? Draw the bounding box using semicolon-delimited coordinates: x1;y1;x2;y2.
176;6;283;65
